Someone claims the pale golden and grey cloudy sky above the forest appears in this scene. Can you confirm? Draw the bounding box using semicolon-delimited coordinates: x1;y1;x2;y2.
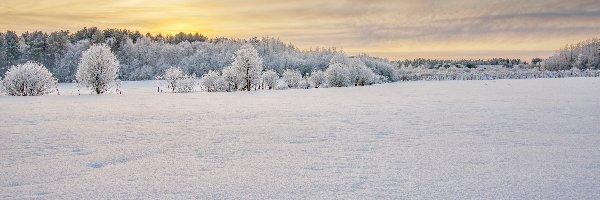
0;0;600;60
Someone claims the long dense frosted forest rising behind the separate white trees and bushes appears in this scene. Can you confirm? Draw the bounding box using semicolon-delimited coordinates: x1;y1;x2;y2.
0;28;356;82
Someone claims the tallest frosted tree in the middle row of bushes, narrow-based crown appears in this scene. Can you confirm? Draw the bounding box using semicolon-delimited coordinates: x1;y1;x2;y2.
231;44;263;91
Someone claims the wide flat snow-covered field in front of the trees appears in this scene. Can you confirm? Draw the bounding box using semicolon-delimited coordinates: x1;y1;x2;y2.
0;78;600;199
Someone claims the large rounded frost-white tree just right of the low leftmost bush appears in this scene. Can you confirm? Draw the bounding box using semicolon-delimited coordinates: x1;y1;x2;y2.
76;44;119;94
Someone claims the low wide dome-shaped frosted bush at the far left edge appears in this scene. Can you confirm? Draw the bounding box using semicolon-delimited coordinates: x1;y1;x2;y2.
0;62;58;96
